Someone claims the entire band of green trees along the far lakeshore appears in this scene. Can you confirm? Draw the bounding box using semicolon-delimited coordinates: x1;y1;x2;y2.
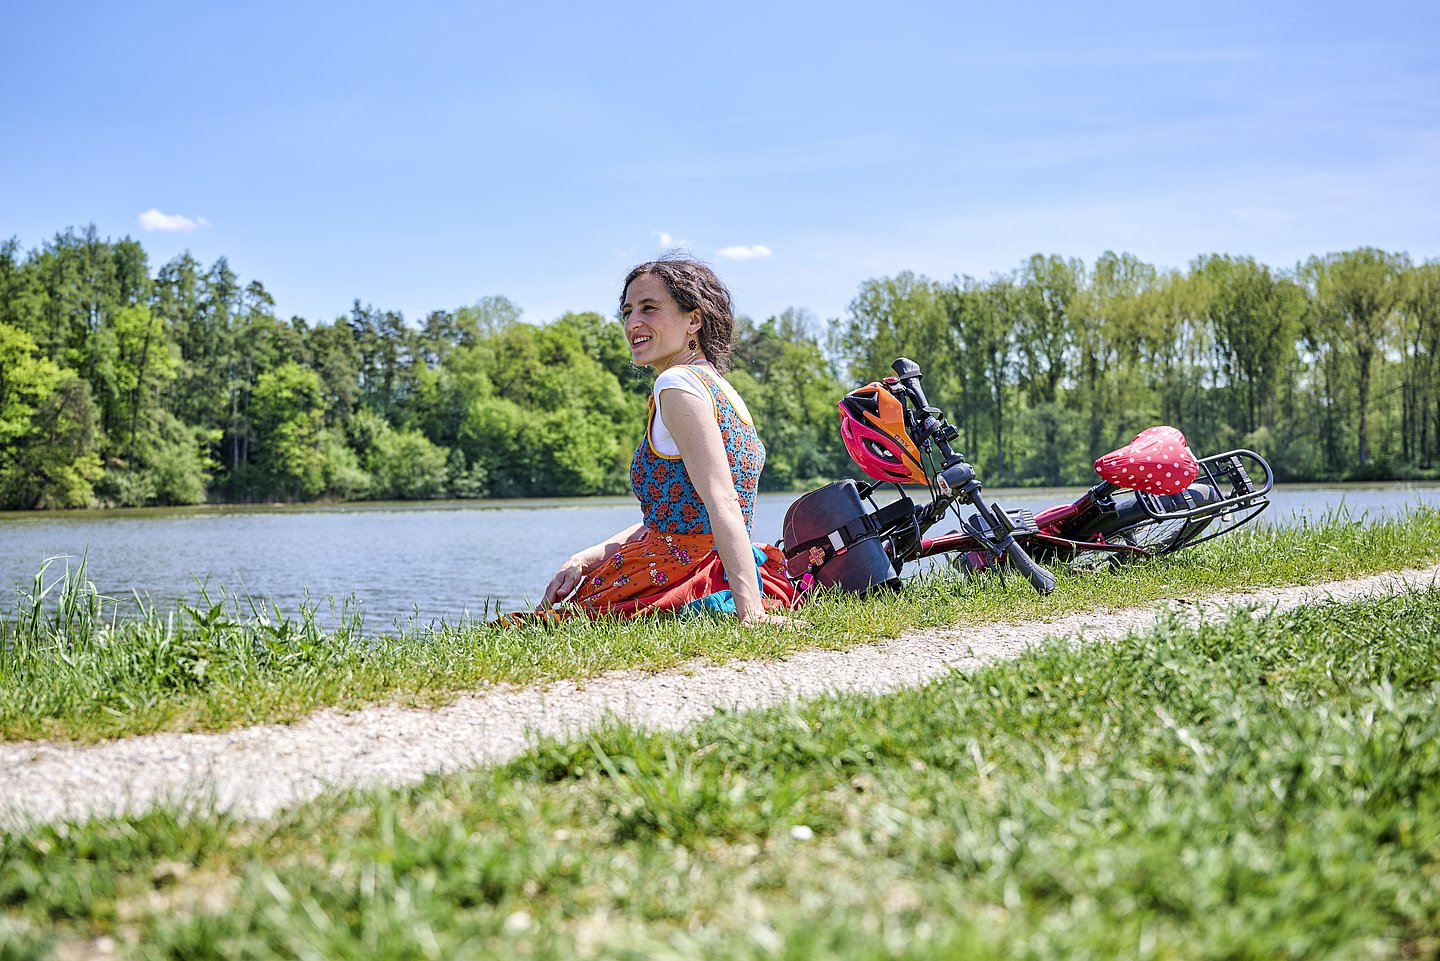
0;226;1440;509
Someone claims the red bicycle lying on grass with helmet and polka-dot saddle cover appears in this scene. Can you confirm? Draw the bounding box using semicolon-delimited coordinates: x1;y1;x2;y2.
782;357;1274;594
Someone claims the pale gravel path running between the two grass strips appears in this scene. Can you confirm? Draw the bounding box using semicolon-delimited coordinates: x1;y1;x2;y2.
0;566;1440;826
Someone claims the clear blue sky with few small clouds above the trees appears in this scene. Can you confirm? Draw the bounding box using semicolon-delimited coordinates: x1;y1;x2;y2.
0;0;1440;323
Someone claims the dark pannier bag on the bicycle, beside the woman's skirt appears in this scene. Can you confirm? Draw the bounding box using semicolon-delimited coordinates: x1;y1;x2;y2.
782;480;900;594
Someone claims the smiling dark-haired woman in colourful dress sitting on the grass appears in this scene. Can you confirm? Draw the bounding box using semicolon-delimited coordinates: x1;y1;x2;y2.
537;259;795;625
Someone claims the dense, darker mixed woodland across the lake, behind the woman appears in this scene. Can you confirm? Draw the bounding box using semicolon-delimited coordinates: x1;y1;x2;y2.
0;226;844;509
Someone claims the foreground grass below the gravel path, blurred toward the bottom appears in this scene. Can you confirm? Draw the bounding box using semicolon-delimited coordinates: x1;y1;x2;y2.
0;589;1440;961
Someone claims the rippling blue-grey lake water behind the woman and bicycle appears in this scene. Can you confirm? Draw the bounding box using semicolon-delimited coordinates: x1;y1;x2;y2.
0;484;1440;630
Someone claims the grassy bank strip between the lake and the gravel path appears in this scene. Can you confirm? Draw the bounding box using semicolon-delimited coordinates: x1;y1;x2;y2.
8;509;1440;741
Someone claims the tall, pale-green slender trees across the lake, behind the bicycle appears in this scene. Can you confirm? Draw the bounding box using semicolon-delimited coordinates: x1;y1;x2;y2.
837;248;1440;484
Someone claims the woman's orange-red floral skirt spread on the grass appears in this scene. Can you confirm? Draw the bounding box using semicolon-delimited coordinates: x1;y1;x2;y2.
504;527;798;621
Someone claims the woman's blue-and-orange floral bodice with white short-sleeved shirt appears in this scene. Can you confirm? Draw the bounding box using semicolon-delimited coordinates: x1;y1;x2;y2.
631;366;765;535
